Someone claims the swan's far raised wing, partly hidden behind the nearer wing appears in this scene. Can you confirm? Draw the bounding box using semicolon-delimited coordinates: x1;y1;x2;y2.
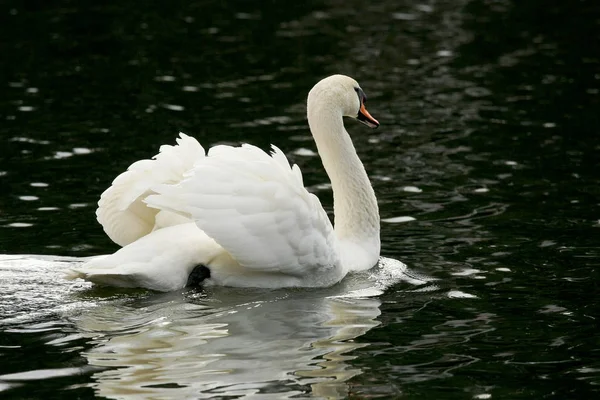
96;133;205;246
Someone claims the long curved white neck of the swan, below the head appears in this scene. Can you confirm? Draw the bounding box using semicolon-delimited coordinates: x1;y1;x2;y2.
308;101;380;256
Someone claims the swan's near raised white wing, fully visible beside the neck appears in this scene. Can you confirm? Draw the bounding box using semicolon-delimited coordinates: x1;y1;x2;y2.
146;144;339;276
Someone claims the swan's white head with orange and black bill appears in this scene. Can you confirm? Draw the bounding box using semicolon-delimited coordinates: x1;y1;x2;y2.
308;75;379;128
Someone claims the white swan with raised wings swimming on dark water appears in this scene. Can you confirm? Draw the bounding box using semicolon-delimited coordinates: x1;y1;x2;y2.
68;75;380;291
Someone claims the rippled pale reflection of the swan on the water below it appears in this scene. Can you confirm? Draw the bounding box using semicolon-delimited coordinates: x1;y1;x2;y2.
73;289;381;398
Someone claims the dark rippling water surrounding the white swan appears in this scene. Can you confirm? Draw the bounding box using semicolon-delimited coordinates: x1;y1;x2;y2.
0;0;600;399
